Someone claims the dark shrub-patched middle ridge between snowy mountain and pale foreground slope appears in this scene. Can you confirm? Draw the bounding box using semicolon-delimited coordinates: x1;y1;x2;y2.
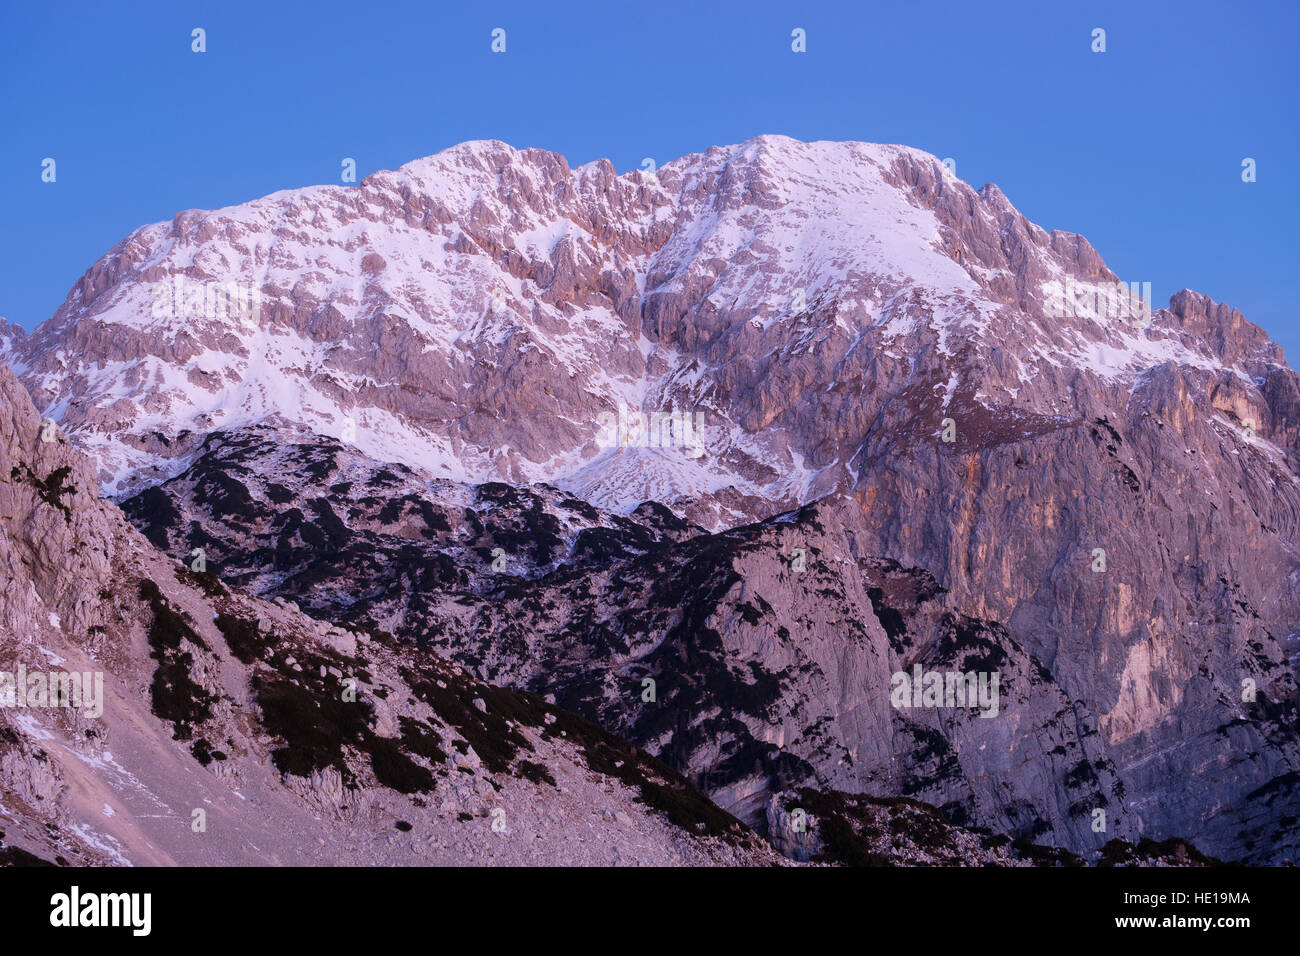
114;423;1294;860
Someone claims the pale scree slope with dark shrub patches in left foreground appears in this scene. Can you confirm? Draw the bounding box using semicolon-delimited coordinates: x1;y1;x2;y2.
0;367;780;865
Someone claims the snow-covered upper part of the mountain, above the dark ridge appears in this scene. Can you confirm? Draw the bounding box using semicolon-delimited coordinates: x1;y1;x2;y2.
4;137;1281;527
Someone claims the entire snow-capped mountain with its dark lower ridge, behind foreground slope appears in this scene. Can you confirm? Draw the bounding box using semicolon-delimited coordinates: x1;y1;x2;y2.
0;137;1300;861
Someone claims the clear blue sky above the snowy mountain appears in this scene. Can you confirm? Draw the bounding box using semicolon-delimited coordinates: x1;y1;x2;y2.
0;0;1300;358
